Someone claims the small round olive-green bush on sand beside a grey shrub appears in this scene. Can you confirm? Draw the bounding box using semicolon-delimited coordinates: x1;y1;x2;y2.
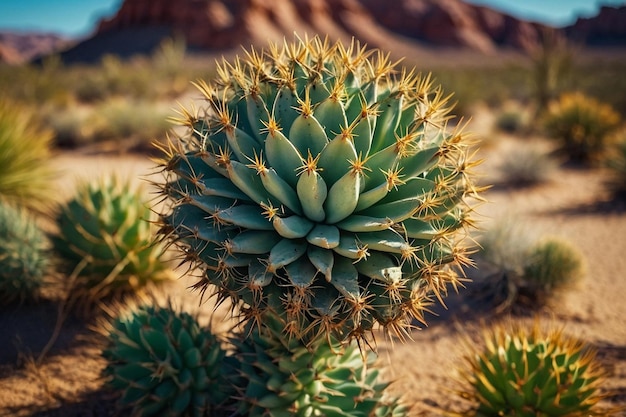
521;237;585;298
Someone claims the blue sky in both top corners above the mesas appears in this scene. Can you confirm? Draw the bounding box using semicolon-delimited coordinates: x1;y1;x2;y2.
0;0;626;37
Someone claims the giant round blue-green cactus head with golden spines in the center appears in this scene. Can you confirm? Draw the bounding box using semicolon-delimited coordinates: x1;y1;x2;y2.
158;37;478;340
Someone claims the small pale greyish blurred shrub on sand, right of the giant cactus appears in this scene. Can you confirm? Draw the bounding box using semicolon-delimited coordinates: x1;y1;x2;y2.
498;142;557;187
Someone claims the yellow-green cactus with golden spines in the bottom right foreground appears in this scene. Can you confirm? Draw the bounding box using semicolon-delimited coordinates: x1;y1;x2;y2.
460;323;607;417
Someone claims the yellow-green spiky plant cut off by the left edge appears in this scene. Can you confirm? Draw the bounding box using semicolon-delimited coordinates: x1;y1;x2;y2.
0;99;54;212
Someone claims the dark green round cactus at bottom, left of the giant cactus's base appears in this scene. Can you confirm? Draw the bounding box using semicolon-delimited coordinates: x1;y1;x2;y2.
102;306;232;416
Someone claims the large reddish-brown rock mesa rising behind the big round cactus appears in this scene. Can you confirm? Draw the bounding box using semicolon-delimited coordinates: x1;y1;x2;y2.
92;0;539;52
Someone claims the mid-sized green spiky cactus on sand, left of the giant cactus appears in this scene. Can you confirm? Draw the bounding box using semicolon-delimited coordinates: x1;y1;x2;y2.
53;177;172;299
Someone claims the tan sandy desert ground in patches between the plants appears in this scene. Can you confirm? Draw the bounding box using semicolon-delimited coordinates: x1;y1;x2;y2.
0;125;626;416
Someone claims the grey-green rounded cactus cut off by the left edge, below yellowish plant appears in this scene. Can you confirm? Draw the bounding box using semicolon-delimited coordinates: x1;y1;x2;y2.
0;203;50;304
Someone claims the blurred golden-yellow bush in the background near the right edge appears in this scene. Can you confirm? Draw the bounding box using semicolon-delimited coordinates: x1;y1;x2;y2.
545;93;620;163
